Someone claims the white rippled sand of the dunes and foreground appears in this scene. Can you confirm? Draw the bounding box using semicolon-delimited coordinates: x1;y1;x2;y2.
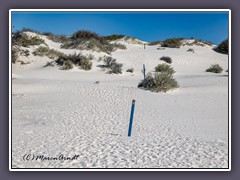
12;32;228;168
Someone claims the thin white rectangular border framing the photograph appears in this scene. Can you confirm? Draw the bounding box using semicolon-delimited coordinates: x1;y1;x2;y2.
9;9;232;171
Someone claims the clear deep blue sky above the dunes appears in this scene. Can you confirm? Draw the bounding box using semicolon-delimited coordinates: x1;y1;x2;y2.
12;12;228;44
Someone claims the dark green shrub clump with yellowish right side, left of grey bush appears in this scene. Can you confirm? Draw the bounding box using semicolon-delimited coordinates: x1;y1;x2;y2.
56;53;92;70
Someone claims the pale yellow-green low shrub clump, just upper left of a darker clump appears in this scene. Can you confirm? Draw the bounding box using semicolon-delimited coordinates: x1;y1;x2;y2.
33;46;64;59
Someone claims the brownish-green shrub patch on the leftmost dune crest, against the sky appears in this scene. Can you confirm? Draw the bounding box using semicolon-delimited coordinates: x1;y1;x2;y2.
12;31;46;47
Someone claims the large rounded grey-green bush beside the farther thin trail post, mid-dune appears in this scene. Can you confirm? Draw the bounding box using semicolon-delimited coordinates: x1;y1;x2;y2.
138;64;179;92
